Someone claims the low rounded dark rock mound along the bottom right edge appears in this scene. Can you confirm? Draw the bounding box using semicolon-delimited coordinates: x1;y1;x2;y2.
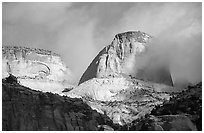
123;115;197;131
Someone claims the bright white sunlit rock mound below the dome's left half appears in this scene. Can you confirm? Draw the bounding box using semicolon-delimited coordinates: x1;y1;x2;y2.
64;77;131;101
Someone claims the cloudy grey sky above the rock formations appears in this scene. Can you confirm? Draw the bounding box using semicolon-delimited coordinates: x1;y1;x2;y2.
2;2;202;86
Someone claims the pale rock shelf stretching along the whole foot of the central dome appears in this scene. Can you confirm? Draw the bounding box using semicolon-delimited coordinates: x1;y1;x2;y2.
64;77;176;101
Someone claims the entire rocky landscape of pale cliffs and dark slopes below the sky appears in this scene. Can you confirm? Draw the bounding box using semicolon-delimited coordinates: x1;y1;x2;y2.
2;31;202;131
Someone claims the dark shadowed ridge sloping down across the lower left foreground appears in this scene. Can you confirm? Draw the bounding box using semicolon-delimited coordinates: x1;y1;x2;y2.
2;78;115;131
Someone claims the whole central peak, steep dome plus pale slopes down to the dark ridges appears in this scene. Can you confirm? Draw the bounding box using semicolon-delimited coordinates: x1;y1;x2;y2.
64;31;175;125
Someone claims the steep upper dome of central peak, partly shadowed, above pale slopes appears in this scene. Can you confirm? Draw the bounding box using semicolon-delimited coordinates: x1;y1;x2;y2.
79;31;173;85
